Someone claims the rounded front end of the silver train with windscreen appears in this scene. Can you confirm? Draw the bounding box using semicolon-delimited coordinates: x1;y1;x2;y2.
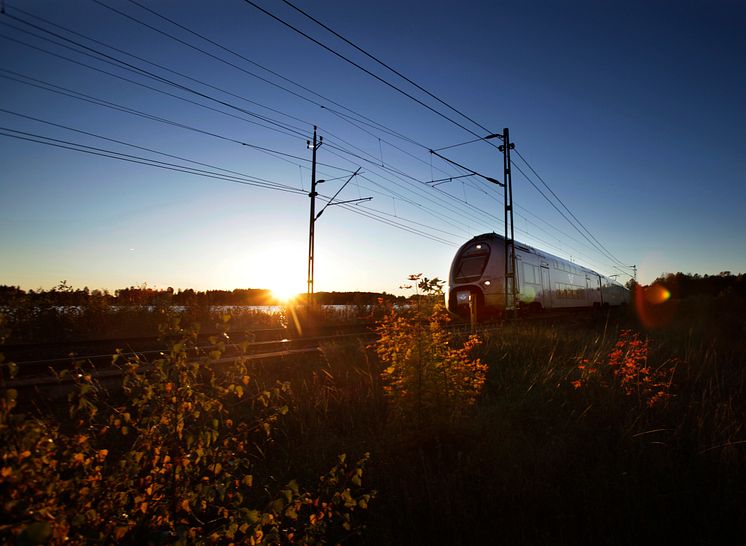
446;233;505;320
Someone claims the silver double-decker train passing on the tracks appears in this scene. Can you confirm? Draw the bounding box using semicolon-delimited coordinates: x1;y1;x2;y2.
446;233;630;320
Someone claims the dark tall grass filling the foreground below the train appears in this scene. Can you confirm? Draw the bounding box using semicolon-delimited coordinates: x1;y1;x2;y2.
1;299;746;545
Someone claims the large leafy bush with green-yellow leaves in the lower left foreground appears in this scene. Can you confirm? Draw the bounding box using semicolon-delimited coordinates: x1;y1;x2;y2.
0;322;372;544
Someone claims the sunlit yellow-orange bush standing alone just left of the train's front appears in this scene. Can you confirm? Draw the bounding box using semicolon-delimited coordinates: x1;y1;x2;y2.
375;275;487;427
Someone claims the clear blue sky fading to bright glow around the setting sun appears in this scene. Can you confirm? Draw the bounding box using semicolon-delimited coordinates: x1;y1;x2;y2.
0;0;746;293
